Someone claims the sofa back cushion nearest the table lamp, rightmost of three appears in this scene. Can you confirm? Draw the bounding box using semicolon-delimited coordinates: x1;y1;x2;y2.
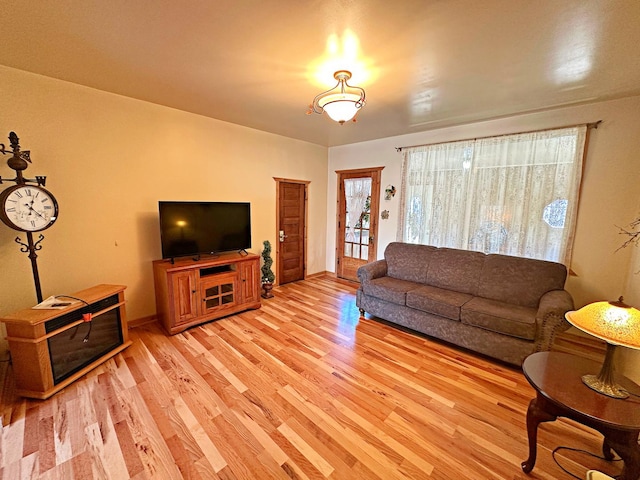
478;254;567;307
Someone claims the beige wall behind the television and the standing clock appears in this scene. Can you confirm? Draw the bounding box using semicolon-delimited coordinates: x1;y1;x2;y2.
0;66;327;353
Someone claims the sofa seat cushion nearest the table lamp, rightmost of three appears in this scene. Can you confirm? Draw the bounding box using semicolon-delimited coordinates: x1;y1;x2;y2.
460;297;537;340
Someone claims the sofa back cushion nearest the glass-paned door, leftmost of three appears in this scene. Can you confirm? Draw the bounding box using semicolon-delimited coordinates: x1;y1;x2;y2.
384;242;438;283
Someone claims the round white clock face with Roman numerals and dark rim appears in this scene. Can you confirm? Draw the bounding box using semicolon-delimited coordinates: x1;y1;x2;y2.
0;185;58;232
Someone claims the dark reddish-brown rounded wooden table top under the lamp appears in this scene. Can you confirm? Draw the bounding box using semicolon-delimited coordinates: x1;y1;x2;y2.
522;352;640;430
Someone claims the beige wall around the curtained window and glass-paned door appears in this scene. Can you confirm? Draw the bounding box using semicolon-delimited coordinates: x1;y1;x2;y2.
326;97;640;380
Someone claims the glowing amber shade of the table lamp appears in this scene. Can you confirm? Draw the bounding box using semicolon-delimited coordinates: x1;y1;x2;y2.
565;299;640;349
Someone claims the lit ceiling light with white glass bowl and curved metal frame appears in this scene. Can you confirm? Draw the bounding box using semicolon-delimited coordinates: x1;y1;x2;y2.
307;70;365;125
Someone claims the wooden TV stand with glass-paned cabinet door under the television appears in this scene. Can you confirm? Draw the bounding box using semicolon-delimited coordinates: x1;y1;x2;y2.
153;252;260;335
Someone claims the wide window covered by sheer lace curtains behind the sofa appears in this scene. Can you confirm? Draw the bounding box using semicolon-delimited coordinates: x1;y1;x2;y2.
398;125;587;265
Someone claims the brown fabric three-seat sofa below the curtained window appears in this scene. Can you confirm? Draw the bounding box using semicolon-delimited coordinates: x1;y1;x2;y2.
356;242;573;366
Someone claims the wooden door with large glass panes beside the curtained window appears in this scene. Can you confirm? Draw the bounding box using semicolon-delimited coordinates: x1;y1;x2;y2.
336;167;384;281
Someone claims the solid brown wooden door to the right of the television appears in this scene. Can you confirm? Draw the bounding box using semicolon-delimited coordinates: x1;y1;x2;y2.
276;179;309;285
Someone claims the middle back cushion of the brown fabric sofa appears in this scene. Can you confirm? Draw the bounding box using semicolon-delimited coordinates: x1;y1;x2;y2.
426;248;485;295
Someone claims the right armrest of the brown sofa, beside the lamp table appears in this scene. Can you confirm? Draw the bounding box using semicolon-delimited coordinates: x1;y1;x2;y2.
535;290;573;352
